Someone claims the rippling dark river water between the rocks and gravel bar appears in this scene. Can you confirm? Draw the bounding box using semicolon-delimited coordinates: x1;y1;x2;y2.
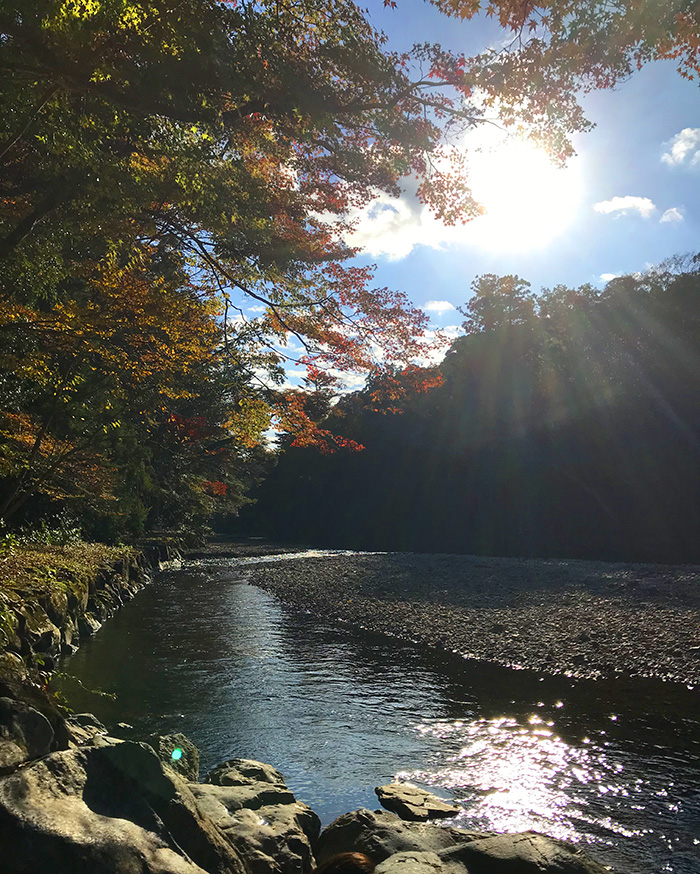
62;558;700;874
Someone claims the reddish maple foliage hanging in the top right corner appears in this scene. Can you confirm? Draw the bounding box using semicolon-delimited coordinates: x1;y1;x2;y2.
431;0;700;119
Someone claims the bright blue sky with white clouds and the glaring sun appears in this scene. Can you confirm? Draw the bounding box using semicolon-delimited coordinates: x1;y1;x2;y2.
242;0;700;387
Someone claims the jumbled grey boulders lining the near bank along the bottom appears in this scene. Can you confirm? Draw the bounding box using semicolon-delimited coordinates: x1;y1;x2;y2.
0;697;607;874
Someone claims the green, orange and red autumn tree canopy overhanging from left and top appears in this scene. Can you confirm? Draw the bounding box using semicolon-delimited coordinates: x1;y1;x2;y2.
0;0;697;530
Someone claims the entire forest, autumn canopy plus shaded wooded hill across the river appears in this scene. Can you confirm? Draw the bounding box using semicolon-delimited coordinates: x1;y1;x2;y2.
0;0;698;558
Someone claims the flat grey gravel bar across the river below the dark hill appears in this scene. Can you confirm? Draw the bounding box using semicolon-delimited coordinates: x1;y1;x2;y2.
246;553;700;685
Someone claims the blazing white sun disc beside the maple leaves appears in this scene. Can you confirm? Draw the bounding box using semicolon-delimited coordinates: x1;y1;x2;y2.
466;139;581;251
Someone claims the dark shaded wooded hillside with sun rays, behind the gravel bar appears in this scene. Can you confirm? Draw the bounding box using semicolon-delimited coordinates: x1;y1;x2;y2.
243;257;700;562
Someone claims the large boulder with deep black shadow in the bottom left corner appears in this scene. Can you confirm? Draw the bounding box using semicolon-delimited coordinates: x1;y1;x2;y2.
0;736;246;874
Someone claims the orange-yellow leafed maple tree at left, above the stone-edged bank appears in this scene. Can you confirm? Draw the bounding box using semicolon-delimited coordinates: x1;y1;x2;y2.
0;250;269;528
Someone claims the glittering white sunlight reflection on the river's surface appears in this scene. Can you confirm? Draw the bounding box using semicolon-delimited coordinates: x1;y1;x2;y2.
396;714;674;843
